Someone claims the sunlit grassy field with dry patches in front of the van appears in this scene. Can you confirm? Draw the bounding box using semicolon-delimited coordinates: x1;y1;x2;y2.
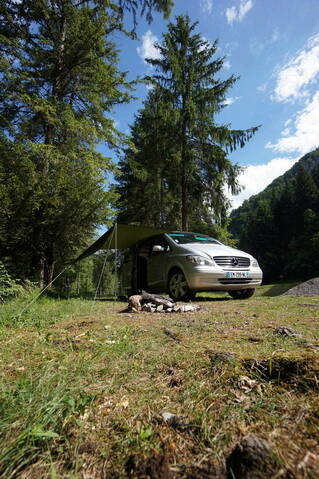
0;284;319;479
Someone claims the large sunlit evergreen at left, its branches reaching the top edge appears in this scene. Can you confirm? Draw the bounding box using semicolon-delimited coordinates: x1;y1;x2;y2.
0;0;172;285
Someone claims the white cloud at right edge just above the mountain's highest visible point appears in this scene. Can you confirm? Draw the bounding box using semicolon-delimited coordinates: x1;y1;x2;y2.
266;91;319;154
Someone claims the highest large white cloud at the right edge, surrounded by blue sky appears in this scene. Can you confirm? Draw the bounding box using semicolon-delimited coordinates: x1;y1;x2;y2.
272;34;319;102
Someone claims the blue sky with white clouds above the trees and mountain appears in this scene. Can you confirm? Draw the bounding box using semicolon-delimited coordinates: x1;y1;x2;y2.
99;0;319;207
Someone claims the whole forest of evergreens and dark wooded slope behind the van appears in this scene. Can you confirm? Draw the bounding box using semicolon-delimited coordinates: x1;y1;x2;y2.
0;0;319;294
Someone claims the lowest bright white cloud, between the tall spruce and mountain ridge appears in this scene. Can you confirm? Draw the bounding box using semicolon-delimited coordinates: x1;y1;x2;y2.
230;158;298;209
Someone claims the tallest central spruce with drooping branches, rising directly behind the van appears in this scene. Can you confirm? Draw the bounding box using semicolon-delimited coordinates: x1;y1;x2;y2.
142;16;258;230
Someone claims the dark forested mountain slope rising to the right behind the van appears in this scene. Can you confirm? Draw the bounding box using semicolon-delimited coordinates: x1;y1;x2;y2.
230;148;319;280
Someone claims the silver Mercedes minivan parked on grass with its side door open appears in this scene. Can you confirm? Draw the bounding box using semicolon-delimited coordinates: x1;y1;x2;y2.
121;231;262;301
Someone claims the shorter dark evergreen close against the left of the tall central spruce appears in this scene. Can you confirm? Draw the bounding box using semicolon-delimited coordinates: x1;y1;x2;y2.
117;88;180;227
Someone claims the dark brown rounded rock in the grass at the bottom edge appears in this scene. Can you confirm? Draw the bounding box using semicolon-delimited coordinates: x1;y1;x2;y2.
226;435;278;479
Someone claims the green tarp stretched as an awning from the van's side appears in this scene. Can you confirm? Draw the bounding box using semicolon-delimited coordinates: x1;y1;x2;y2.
73;224;170;263
